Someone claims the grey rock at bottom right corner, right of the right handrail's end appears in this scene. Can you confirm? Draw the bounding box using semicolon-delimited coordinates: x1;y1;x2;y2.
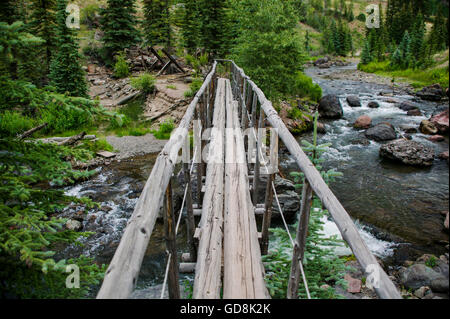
399;264;448;292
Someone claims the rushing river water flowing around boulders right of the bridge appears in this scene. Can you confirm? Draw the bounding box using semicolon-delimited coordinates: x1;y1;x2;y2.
302;65;449;260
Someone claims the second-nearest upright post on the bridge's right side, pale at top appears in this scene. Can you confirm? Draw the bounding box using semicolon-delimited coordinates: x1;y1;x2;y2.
261;130;278;255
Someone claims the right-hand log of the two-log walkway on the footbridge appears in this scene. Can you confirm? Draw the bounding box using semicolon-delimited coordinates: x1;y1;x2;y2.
223;81;270;299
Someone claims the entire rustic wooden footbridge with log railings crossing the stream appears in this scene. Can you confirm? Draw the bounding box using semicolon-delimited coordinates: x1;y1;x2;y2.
97;60;401;299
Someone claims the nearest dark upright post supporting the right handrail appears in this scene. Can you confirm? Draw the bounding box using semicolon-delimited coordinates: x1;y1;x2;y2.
287;178;313;299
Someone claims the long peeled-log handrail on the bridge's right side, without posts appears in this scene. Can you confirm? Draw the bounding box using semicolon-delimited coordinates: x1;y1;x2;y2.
225;60;402;299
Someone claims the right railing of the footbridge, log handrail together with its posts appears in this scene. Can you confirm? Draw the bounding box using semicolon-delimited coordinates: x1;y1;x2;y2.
221;60;401;299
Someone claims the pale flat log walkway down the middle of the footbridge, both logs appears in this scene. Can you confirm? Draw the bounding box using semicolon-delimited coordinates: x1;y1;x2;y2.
194;79;269;299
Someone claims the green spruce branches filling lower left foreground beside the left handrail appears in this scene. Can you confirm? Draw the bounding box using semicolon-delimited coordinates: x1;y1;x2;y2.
0;138;108;297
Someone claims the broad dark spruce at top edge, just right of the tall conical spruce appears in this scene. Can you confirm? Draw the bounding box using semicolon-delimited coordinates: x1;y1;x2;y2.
101;0;140;63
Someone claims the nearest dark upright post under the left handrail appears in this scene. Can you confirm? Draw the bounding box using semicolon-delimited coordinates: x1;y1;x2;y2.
164;181;180;299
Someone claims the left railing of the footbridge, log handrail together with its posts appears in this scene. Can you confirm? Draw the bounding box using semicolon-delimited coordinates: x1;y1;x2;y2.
97;62;217;299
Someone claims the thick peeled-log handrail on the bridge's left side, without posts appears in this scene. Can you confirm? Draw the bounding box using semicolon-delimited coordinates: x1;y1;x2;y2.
97;62;217;299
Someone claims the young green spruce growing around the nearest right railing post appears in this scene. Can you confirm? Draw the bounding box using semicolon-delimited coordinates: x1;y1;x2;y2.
263;114;349;299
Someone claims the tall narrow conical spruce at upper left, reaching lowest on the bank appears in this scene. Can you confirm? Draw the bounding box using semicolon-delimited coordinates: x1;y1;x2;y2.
49;0;87;97
